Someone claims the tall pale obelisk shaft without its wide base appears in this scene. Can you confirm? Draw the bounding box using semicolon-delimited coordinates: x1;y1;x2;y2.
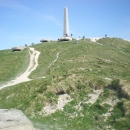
63;7;69;37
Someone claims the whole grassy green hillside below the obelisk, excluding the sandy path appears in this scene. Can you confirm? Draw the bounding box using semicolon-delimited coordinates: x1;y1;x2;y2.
0;38;130;130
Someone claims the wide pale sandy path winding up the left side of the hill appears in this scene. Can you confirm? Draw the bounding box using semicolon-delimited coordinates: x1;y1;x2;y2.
0;48;40;90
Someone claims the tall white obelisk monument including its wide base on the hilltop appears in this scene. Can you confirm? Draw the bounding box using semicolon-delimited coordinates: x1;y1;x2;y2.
59;7;72;41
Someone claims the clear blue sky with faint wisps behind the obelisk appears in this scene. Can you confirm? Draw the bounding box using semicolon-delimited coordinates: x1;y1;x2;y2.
0;0;130;50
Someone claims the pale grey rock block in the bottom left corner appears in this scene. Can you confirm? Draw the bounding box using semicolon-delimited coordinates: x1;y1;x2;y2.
0;109;35;130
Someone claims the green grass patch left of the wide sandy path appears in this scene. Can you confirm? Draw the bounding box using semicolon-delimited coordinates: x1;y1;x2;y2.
0;49;29;84
